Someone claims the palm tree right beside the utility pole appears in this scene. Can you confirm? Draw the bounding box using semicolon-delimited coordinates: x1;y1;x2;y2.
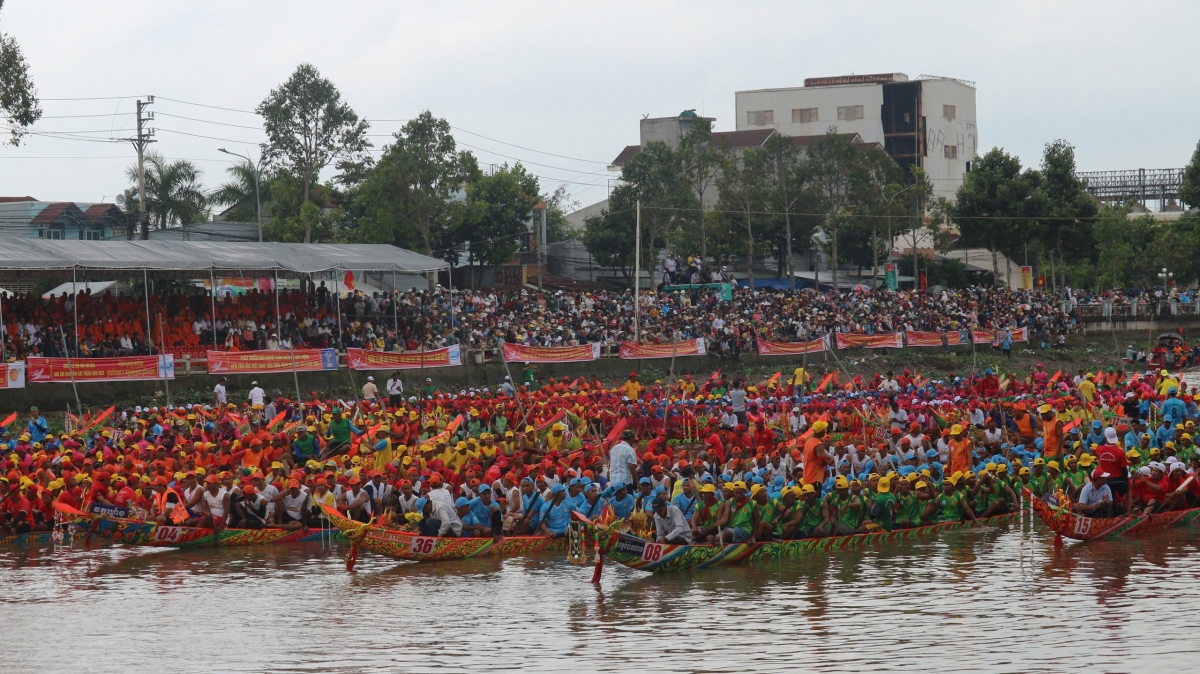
125;151;209;239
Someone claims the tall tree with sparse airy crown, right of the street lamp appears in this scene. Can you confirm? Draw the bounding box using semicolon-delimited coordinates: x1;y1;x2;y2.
256;64;371;243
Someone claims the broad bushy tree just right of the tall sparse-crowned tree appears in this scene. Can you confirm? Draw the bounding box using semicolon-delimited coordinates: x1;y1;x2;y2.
359;110;479;255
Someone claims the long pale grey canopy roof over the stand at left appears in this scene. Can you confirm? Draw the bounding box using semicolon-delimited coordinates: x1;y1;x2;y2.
0;239;449;276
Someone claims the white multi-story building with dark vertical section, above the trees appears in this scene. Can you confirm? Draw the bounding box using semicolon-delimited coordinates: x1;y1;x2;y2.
734;73;979;199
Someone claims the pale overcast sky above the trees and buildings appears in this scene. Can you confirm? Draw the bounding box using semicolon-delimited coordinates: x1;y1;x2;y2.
0;0;1200;205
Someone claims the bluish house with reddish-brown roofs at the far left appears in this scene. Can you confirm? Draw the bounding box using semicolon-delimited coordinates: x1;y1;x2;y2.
0;197;131;241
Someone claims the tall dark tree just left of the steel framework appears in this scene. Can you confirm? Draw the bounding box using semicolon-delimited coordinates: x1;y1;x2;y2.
1039;140;1099;287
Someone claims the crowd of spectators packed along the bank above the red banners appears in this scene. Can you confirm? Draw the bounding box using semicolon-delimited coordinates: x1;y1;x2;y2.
0;278;1076;360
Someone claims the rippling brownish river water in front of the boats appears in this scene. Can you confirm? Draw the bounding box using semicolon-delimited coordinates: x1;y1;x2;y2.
0;522;1200;674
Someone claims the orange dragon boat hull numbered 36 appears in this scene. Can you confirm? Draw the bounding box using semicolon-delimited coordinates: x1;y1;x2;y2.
323;506;568;570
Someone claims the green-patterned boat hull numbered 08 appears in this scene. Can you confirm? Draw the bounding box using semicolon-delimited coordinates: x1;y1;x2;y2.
585;512;1019;572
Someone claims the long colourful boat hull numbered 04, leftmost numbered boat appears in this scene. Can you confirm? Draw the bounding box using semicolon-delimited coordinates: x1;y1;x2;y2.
54;504;346;548
